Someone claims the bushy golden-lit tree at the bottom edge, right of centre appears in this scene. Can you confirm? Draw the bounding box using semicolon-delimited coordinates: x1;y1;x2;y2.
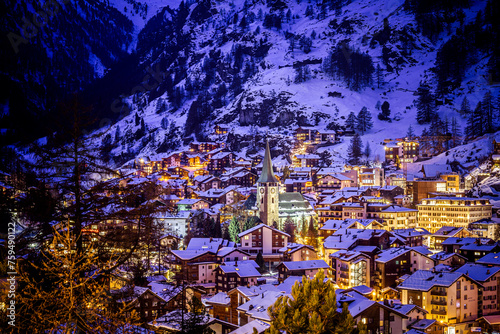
266;270;366;334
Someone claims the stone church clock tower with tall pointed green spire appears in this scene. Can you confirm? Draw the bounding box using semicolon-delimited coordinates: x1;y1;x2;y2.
255;142;279;226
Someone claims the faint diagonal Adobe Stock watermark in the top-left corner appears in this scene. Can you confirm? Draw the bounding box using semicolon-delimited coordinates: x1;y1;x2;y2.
7;0;70;54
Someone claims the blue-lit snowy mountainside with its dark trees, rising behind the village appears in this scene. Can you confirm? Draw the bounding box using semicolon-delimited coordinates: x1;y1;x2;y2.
4;0;500;166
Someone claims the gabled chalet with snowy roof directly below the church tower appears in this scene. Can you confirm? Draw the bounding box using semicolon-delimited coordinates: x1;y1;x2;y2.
238;224;290;268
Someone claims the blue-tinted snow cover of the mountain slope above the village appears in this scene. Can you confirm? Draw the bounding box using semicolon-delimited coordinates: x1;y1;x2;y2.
89;0;498;164
